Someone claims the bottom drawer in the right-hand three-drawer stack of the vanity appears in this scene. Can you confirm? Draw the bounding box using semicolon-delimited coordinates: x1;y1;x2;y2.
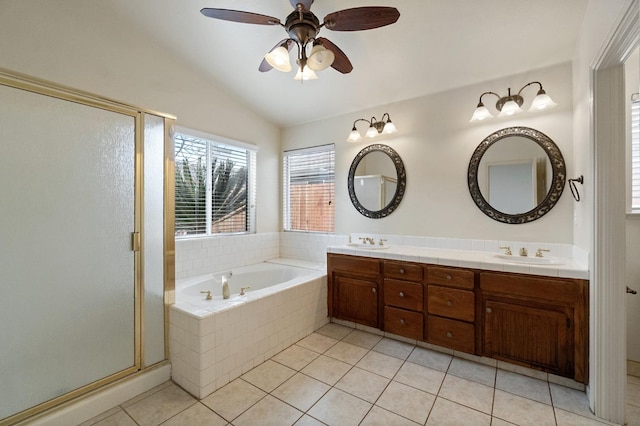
427;315;475;353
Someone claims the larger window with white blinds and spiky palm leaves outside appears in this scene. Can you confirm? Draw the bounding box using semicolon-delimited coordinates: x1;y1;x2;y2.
174;133;256;237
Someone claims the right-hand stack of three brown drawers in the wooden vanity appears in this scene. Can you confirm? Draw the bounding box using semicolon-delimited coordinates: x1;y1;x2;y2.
425;266;476;353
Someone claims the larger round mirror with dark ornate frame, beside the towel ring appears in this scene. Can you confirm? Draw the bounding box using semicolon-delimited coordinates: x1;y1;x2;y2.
467;127;566;224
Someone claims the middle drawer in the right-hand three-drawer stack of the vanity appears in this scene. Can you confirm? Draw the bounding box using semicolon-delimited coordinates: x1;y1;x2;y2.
427;285;475;322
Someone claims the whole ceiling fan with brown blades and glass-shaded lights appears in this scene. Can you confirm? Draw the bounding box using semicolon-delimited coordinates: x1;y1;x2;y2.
200;0;400;80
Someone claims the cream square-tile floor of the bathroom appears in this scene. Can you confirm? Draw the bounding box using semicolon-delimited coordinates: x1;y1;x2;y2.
83;324;640;426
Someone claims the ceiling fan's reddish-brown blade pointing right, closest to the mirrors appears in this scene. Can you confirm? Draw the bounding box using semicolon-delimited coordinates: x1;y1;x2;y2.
324;6;400;31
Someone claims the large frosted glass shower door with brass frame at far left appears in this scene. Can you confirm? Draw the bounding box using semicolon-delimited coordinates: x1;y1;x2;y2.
0;85;140;420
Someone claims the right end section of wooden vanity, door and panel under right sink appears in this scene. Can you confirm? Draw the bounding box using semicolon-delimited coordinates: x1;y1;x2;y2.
480;272;588;383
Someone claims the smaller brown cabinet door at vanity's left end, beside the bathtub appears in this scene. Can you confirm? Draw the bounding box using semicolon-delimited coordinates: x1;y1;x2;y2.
333;273;378;327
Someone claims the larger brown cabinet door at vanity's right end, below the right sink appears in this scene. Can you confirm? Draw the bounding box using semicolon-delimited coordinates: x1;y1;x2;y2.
484;300;573;376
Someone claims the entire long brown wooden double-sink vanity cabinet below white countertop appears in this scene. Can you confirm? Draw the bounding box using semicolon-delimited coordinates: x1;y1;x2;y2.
327;253;588;383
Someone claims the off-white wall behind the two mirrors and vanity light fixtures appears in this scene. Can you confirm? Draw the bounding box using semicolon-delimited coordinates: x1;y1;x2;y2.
282;64;575;244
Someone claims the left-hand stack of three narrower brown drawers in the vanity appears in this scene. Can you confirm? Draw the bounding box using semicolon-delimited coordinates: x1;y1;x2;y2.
382;260;424;340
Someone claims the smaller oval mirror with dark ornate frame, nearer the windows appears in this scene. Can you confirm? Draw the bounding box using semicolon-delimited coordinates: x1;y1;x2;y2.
347;144;407;219
